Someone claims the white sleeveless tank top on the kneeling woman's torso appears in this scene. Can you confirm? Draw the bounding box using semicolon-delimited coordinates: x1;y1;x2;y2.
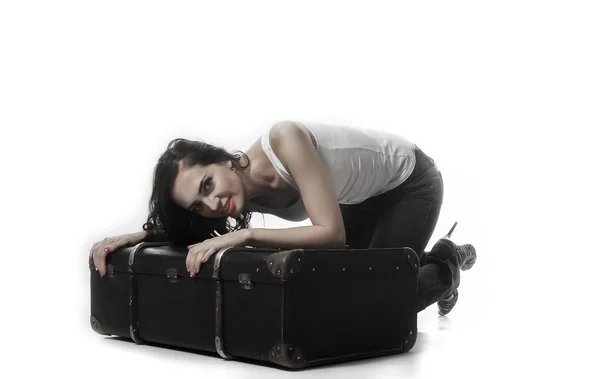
246;121;416;221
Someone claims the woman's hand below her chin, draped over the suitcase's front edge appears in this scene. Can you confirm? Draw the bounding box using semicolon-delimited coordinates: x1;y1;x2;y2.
185;229;250;277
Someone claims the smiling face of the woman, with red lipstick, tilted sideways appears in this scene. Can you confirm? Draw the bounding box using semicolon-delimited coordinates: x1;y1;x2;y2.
172;161;244;218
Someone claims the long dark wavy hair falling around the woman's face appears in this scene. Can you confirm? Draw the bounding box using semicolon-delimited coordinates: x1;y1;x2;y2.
142;138;251;246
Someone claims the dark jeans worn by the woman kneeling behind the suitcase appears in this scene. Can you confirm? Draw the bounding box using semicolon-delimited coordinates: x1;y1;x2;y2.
340;147;459;311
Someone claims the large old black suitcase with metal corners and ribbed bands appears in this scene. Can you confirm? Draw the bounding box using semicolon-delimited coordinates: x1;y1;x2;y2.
89;242;419;369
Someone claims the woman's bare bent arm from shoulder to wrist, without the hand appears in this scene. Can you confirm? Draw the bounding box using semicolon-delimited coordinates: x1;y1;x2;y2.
249;121;346;248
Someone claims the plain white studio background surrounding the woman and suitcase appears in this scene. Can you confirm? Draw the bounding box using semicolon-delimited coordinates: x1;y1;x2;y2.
0;0;600;378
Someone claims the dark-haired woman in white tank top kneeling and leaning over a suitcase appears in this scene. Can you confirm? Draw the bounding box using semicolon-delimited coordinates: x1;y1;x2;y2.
90;121;476;314
